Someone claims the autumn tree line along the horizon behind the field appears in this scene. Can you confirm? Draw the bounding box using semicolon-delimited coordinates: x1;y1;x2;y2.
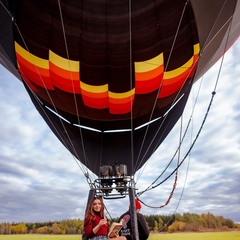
0;213;240;234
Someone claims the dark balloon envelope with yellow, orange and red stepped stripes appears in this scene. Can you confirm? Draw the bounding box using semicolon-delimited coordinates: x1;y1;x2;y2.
0;0;240;237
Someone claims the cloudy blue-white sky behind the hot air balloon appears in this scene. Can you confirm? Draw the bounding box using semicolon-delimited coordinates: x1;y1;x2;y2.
0;40;240;222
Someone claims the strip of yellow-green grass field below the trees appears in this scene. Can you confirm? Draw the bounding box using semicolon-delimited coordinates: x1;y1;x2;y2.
0;231;240;240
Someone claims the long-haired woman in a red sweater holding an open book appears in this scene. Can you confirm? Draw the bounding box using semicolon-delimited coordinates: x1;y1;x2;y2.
84;197;126;240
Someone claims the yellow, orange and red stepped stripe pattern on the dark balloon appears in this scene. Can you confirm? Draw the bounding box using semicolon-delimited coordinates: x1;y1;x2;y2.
15;42;200;114
